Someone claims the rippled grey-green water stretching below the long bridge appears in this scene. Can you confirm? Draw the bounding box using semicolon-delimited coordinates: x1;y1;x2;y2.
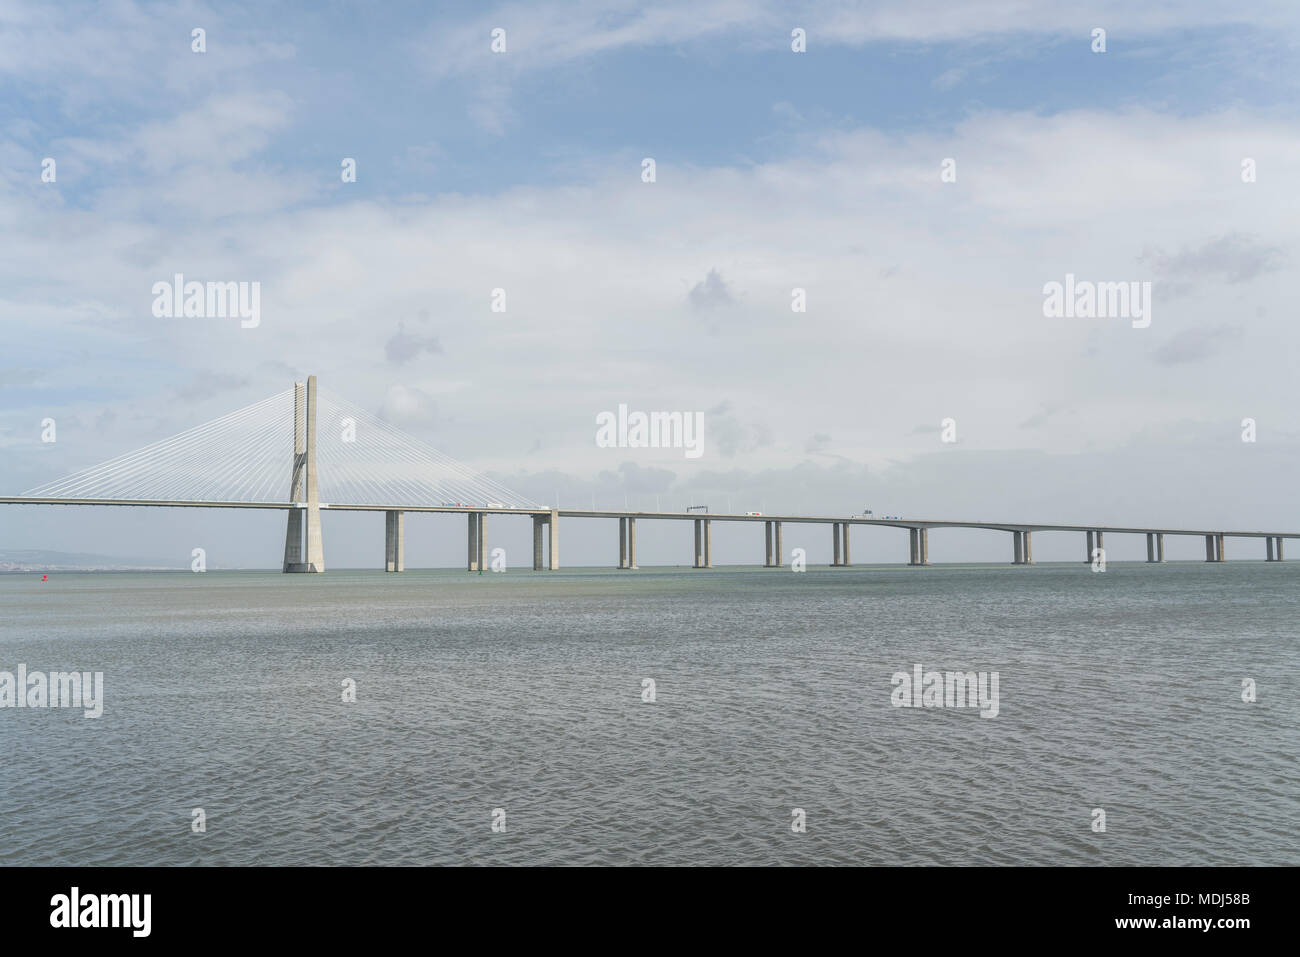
0;562;1300;865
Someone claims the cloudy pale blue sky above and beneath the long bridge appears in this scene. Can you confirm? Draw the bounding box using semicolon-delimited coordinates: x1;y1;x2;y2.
0;0;1300;567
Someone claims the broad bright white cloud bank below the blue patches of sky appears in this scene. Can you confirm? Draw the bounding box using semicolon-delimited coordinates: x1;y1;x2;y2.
0;102;1300;478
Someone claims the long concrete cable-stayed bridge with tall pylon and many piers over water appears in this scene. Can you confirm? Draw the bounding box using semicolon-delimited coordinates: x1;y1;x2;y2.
0;376;1300;573
